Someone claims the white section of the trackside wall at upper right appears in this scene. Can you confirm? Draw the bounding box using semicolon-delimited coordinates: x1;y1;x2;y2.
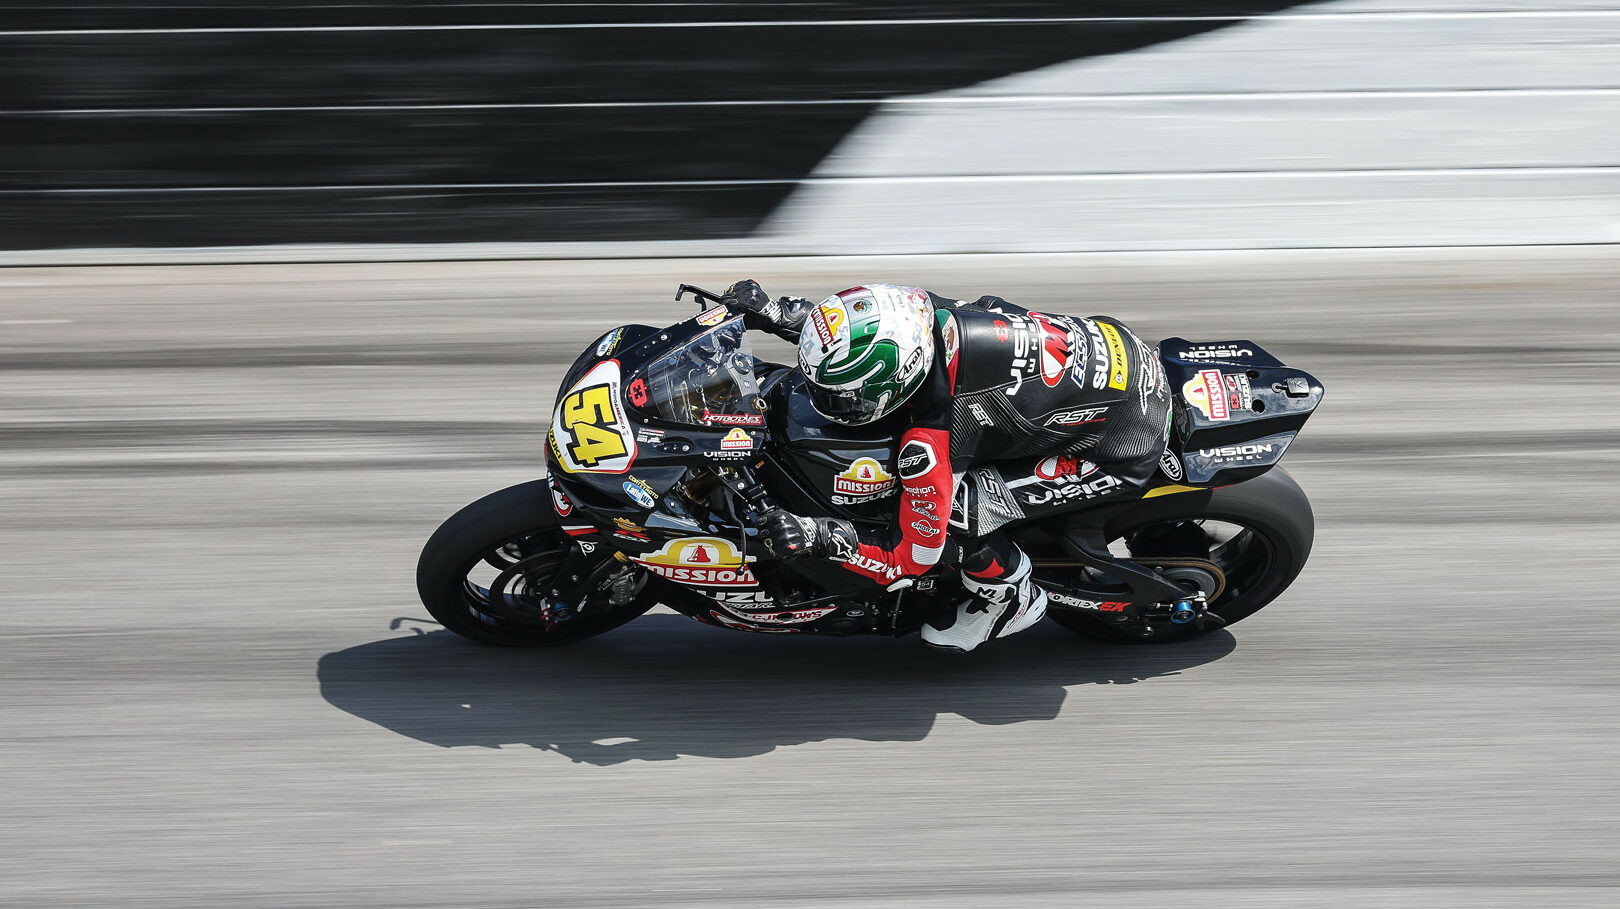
757;0;1620;253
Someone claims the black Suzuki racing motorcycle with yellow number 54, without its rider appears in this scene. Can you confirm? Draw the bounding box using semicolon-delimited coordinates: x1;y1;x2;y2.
416;284;1322;647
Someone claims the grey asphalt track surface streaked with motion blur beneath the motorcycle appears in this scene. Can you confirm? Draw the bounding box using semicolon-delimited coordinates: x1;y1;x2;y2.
0;248;1620;909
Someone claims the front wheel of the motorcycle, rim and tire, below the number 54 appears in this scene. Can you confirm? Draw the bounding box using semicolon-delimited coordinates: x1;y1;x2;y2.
416;480;653;647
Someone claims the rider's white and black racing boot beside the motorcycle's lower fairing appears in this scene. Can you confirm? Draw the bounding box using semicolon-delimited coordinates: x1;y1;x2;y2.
922;548;1047;653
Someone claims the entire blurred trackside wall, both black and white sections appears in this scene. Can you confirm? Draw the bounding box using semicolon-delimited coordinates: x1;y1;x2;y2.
0;0;1620;253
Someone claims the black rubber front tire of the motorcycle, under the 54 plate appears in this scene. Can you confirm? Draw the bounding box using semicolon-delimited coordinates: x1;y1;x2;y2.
416;480;653;647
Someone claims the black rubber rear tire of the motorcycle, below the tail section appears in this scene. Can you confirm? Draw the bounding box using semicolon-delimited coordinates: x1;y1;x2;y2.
1037;468;1315;643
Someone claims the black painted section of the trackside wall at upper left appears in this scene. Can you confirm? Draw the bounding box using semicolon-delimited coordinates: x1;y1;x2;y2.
0;0;1321;248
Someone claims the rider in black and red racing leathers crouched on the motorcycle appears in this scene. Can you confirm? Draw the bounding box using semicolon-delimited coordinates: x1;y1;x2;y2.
726;280;1170;651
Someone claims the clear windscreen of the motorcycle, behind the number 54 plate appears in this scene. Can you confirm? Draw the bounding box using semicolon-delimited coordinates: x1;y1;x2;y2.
632;316;765;426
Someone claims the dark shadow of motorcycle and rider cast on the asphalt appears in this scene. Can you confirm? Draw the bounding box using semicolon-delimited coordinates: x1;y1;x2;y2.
319;614;1236;765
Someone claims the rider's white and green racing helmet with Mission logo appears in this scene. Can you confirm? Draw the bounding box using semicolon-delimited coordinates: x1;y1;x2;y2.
799;284;933;425
